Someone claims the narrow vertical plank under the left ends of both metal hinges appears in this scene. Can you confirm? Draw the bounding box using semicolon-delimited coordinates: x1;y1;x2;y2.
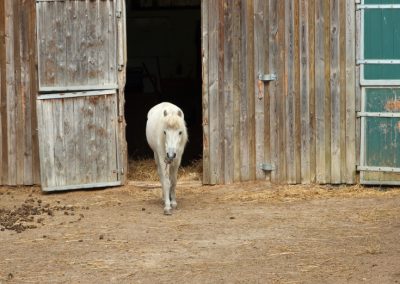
253;0;269;179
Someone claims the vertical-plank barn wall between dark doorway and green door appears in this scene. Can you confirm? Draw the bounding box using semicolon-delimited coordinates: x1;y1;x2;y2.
202;0;356;184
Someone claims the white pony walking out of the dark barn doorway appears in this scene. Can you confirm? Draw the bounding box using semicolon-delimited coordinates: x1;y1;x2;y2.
146;102;188;215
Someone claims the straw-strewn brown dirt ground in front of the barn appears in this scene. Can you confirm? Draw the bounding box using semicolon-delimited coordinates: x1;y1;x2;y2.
0;182;400;283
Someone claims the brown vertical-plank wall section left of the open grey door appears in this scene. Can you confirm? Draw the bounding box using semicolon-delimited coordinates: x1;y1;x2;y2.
0;0;39;185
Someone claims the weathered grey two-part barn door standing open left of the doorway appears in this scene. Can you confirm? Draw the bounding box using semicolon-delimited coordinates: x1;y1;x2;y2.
36;0;125;191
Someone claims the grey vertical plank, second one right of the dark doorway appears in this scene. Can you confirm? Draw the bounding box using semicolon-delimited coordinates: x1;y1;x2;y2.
209;0;221;184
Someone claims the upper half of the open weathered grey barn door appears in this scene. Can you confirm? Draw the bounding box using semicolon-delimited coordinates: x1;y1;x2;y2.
36;1;117;91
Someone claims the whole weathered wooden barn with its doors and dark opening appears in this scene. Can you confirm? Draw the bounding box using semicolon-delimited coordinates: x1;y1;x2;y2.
0;0;400;191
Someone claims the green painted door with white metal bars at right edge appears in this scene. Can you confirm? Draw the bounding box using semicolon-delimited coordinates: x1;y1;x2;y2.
359;0;400;184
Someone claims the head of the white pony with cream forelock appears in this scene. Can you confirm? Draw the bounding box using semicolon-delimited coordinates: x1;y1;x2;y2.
163;110;187;164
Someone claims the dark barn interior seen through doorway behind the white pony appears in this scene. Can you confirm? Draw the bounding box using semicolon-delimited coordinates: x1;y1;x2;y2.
125;0;203;165
